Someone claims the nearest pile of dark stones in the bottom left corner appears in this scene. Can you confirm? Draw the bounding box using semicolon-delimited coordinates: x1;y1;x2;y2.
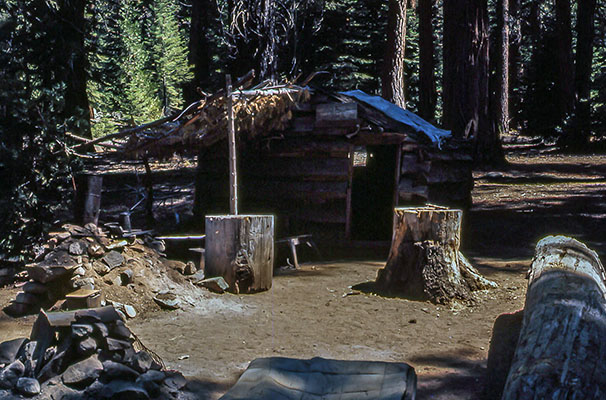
0;307;189;399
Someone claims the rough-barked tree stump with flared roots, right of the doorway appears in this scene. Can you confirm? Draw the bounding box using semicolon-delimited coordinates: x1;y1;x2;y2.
376;205;496;304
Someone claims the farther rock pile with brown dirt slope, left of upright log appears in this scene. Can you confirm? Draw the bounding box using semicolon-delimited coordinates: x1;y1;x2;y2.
4;224;207;317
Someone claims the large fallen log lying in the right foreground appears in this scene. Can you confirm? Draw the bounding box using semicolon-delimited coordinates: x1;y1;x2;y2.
503;236;606;400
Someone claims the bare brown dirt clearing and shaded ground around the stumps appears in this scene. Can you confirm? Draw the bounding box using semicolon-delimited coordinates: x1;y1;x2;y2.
0;148;606;399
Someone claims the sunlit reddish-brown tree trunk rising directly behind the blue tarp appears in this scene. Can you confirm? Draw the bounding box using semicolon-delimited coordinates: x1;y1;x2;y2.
381;0;406;108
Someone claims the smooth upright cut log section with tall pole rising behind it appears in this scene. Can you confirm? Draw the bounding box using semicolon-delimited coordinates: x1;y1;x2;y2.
204;215;274;293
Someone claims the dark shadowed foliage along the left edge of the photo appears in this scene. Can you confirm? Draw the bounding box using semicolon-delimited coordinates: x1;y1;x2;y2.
0;0;77;258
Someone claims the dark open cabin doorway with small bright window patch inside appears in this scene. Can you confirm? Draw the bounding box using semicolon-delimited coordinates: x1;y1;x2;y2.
351;145;397;240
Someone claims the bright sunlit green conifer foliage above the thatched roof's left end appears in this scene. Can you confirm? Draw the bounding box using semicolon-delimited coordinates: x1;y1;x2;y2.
89;0;192;136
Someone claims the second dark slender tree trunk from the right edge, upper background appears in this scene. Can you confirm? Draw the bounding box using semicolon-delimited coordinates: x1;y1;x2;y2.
555;0;574;117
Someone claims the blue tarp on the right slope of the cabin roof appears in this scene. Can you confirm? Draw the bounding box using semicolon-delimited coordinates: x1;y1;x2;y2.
341;90;450;147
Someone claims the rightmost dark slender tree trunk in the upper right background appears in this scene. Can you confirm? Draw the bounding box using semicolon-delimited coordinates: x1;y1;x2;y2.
573;0;596;147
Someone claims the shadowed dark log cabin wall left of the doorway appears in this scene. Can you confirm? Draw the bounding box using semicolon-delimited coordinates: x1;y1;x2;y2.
241;135;351;239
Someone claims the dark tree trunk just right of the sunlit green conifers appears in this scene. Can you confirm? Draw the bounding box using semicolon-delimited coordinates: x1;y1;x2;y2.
188;0;217;97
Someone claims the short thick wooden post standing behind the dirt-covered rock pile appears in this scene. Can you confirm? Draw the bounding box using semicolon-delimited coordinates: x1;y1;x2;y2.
74;173;103;225
